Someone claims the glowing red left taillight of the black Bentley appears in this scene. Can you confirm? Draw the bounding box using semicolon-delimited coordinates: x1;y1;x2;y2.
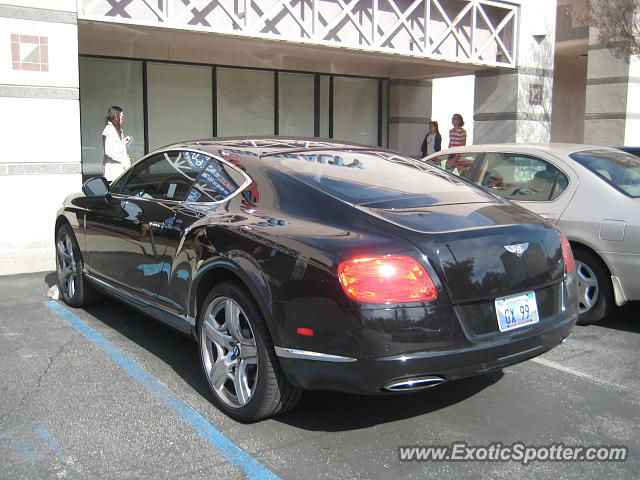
338;255;437;303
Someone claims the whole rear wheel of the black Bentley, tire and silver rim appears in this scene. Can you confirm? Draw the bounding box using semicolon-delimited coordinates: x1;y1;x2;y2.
198;281;302;422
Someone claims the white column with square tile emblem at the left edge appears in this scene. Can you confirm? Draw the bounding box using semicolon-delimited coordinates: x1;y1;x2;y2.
0;0;82;275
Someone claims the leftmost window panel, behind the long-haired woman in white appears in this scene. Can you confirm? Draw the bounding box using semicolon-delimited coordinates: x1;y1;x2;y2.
78;57;145;178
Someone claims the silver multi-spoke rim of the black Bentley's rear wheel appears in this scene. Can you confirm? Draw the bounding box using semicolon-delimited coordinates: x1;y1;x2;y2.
200;297;258;408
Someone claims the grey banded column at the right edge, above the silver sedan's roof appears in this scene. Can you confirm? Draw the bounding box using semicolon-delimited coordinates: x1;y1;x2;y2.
584;29;640;143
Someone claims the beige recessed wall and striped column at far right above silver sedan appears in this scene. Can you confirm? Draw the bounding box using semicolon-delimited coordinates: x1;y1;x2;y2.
552;0;640;146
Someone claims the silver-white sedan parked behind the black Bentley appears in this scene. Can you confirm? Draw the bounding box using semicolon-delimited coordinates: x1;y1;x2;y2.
423;143;640;325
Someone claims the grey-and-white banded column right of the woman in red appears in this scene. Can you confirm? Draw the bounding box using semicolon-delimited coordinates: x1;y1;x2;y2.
473;0;556;144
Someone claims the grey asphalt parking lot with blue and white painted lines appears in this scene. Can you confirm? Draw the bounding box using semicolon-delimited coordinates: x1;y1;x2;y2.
0;273;640;479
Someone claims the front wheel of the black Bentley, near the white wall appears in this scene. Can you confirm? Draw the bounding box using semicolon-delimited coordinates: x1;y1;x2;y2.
56;224;99;307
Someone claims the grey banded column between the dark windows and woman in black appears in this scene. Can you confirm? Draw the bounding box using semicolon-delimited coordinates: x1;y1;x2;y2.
389;80;432;158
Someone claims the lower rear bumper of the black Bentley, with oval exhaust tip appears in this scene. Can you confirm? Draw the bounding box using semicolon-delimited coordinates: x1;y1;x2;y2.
279;313;577;394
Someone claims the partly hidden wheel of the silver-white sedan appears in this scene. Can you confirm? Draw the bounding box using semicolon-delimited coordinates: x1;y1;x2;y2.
573;248;614;325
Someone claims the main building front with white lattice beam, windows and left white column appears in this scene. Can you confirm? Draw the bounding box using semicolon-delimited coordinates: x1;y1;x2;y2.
0;0;556;274
